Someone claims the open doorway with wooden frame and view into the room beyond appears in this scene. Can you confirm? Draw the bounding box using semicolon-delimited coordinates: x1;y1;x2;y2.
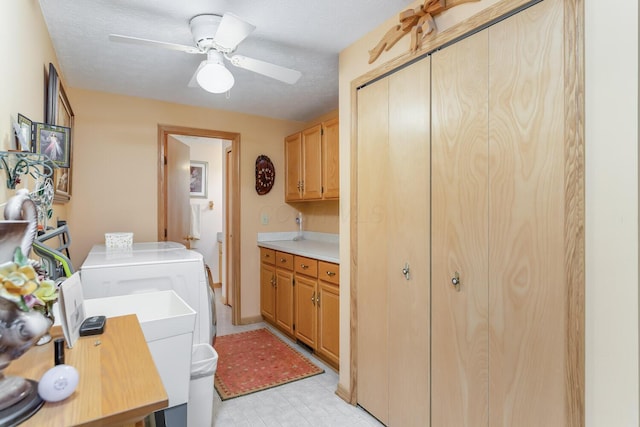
158;125;241;324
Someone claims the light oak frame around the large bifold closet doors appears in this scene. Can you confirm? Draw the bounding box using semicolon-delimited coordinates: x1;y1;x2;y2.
348;0;585;426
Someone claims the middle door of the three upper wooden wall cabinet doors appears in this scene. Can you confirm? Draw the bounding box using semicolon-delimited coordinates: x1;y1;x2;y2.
302;125;322;200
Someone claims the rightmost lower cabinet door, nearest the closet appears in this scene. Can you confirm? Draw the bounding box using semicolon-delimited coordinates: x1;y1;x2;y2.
317;281;340;368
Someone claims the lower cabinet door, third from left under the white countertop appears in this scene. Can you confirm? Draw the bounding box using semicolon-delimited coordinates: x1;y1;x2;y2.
295;274;318;349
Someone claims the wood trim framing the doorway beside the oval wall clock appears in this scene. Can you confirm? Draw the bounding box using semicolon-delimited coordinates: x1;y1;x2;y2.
158;125;241;325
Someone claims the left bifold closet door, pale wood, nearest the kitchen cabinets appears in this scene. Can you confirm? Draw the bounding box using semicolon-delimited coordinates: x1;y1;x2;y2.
356;58;430;426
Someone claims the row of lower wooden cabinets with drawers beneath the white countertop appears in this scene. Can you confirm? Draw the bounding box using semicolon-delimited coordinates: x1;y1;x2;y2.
260;248;340;369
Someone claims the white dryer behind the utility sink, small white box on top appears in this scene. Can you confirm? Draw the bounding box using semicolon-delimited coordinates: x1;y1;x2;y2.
80;242;216;345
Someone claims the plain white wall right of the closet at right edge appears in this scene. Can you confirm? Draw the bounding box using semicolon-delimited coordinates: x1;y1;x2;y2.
585;0;640;427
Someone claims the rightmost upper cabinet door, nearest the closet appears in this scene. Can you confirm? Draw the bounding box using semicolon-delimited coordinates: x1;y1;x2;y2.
322;118;340;200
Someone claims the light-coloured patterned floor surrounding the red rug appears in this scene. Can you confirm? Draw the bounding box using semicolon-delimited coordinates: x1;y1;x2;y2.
213;302;382;427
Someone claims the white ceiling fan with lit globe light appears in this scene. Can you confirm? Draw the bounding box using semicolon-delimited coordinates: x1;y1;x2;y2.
109;13;301;93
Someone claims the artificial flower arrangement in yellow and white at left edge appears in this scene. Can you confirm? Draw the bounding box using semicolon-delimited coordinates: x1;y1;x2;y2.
0;247;58;316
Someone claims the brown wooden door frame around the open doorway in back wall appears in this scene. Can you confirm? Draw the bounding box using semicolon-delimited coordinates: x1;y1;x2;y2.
158;124;241;325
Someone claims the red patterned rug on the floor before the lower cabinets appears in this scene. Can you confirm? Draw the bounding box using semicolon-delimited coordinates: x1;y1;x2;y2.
214;329;324;400
